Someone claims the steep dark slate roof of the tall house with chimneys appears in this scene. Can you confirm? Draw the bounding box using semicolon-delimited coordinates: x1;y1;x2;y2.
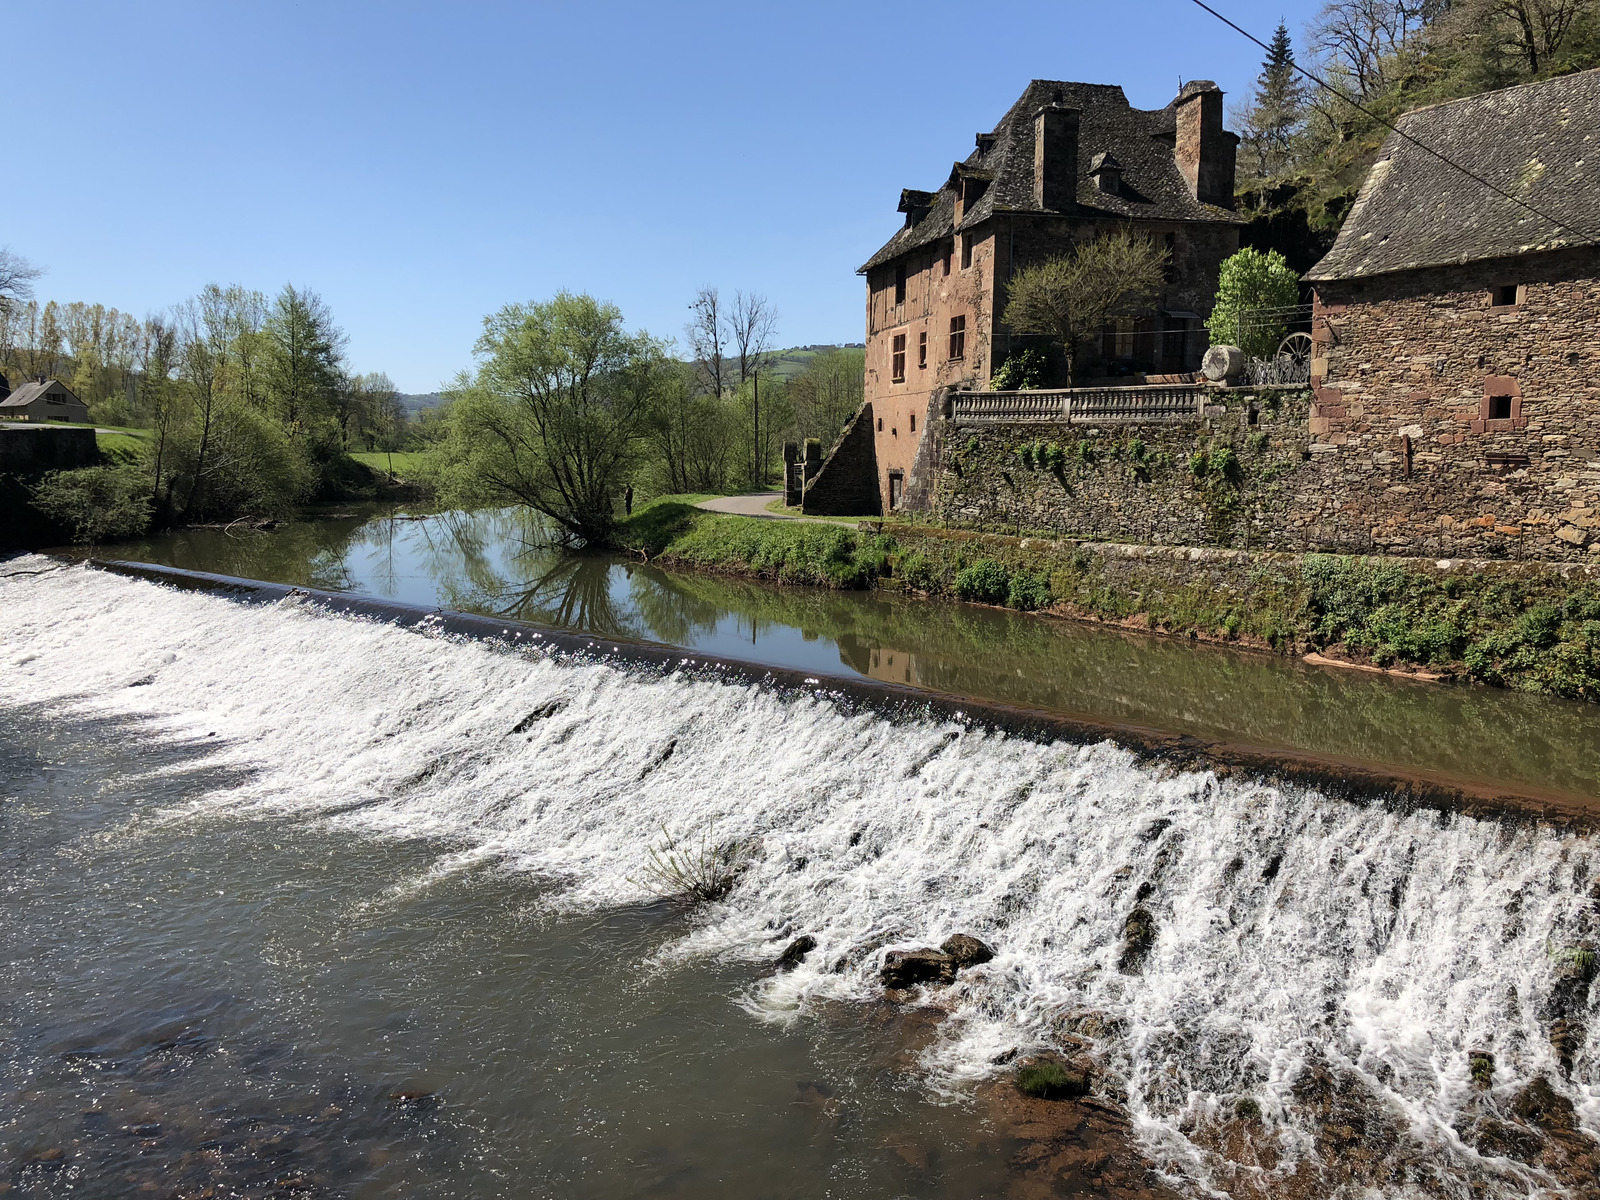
858;78;1243;274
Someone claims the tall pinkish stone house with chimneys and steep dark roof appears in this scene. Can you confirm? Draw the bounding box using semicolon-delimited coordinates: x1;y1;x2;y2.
858;80;1240;509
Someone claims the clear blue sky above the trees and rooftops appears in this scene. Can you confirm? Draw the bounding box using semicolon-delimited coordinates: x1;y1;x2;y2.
0;0;1315;392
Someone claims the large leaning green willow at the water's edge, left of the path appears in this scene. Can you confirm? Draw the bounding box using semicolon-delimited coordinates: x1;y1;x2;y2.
434;291;672;546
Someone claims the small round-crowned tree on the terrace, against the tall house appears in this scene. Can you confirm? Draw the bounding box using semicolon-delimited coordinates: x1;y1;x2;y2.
1005;227;1168;379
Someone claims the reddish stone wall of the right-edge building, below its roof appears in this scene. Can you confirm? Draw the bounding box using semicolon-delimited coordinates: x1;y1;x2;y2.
1296;250;1600;560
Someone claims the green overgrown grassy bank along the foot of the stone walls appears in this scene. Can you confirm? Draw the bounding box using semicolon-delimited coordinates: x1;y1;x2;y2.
618;498;1600;701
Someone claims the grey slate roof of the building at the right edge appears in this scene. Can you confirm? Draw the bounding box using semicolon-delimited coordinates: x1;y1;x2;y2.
1306;69;1600;280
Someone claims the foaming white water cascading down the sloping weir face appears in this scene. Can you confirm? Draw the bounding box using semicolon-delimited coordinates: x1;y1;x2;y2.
0;560;1600;1197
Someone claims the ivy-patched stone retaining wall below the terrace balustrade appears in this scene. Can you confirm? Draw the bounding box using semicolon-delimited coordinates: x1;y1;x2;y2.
915;389;1322;550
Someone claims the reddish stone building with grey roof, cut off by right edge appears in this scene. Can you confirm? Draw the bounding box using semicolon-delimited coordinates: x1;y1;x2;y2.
1302;70;1600;558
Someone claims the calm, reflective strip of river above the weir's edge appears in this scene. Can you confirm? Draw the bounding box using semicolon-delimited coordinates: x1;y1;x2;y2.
100;510;1600;797
